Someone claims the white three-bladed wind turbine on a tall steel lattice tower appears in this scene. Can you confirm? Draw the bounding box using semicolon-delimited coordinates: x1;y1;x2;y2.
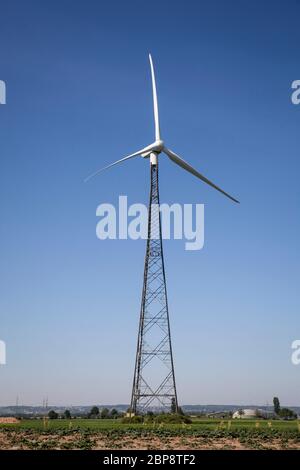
85;54;239;414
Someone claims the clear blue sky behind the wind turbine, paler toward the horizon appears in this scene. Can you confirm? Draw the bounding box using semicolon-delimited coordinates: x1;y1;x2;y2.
0;0;300;405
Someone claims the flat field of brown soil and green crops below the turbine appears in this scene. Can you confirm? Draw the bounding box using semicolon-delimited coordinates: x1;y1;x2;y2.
0;419;300;450
